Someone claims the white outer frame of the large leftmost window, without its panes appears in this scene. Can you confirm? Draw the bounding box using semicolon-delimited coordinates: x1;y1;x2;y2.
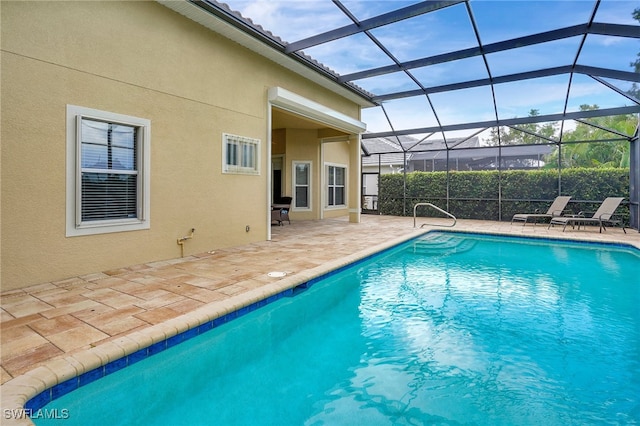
66;105;151;237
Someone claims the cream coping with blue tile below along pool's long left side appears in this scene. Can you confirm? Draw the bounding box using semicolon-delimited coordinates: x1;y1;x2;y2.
3;230;428;422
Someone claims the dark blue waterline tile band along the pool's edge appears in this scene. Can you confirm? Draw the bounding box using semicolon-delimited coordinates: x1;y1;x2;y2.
24;230;640;415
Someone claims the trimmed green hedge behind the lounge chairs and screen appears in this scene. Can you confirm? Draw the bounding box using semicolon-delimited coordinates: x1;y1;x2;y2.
378;168;629;223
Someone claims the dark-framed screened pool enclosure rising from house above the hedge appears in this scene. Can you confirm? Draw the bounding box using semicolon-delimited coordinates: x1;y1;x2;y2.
192;0;640;229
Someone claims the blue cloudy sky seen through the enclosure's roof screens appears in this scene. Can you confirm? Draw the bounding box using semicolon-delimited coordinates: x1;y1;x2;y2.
221;0;640;139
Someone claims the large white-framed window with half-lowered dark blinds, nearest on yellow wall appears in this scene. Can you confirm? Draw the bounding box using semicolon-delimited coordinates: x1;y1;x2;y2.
67;105;151;236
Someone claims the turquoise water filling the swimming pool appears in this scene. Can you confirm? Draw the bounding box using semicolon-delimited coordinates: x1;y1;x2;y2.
35;232;640;425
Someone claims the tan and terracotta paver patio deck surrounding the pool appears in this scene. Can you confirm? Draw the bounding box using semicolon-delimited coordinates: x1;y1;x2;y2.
0;215;640;422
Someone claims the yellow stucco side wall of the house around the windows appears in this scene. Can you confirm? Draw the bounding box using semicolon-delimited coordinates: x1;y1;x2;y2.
0;1;359;291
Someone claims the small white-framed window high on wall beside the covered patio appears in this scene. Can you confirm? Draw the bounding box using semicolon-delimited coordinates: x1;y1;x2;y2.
222;133;260;175
